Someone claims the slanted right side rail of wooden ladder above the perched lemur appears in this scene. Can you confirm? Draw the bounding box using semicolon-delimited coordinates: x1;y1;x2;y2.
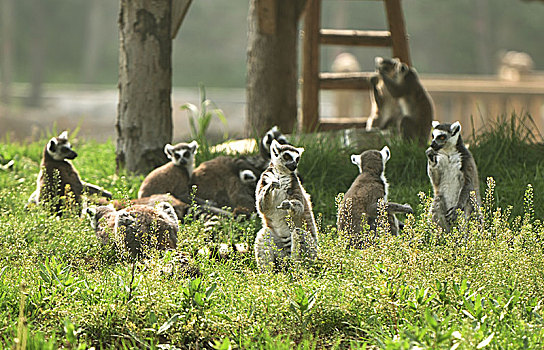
385;0;412;66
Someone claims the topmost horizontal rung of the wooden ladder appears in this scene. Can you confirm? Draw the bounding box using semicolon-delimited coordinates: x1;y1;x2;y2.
319;29;393;47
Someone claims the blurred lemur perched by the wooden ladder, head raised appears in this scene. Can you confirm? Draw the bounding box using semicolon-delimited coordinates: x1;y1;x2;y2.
367;57;434;145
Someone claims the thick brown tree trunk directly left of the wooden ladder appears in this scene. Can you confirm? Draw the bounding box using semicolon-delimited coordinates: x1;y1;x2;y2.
245;0;306;136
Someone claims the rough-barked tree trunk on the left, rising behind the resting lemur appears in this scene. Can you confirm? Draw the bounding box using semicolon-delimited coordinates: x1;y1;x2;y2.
116;0;172;174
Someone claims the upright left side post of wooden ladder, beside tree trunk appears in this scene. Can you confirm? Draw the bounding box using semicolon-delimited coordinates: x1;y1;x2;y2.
301;0;321;132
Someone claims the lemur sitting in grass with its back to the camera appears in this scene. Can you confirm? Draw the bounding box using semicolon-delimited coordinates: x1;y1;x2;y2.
337;146;413;244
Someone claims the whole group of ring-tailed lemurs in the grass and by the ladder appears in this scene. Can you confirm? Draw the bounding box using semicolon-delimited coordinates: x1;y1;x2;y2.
29;57;480;270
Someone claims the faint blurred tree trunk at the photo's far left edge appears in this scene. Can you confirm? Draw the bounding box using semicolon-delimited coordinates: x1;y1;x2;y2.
0;0;14;104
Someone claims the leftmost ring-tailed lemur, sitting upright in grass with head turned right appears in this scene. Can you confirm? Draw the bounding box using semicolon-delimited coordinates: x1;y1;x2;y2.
28;131;111;215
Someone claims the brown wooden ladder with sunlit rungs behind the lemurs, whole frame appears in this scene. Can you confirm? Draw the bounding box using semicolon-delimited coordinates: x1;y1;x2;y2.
301;0;411;132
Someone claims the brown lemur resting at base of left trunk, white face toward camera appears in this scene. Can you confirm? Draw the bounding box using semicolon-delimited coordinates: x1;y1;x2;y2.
138;141;198;201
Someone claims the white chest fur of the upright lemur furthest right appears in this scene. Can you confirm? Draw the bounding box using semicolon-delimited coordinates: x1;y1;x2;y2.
436;152;464;209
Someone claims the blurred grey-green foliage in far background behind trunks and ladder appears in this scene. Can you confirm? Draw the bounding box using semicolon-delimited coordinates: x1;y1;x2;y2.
4;0;544;87
